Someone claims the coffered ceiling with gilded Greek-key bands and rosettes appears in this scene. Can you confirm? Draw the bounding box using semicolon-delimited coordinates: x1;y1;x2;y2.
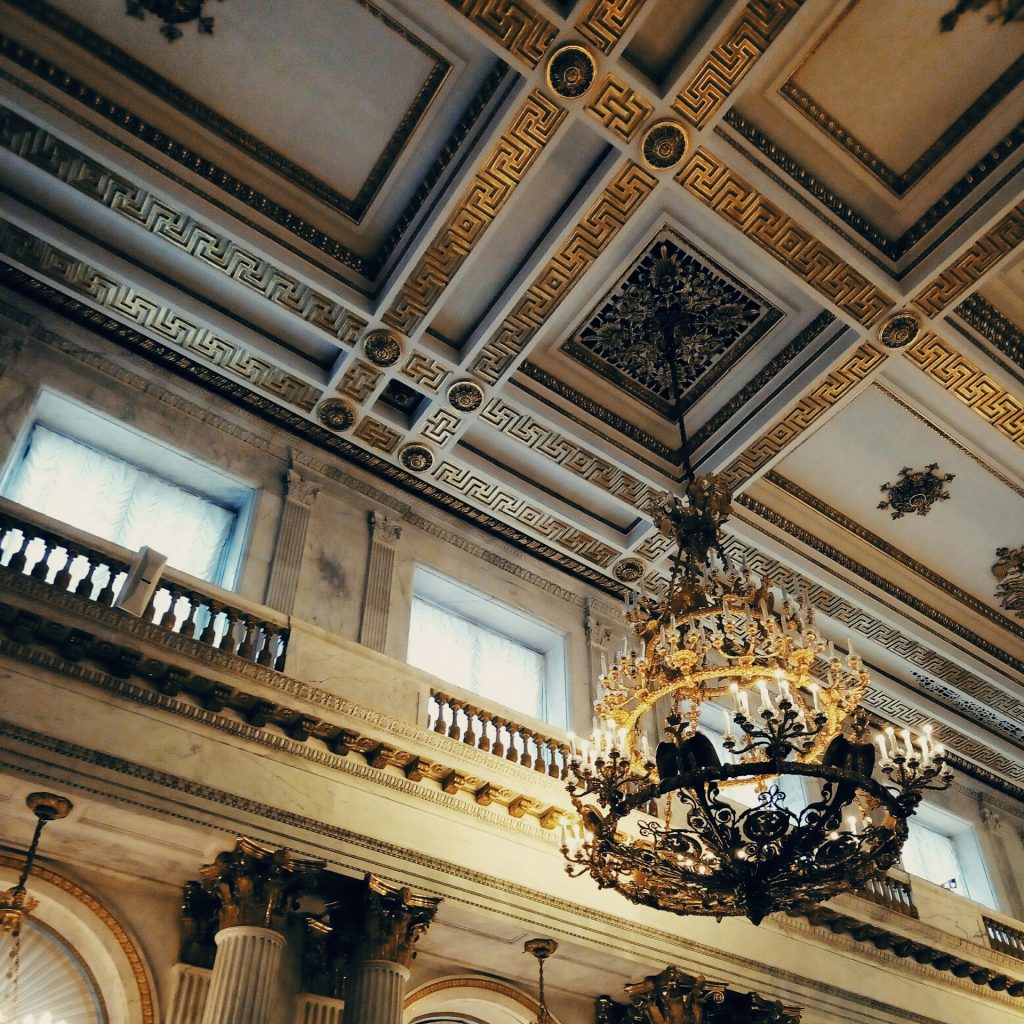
0;0;1024;797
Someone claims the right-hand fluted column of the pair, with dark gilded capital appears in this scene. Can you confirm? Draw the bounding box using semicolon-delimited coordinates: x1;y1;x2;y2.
333;874;440;1024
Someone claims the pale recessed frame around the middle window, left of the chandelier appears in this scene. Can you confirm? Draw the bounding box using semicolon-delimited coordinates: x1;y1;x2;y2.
406;563;569;729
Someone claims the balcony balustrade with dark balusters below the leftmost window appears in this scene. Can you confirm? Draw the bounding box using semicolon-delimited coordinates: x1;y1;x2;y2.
0;499;289;671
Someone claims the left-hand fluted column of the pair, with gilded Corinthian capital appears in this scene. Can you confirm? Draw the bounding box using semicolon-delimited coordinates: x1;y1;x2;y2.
196;839;323;1024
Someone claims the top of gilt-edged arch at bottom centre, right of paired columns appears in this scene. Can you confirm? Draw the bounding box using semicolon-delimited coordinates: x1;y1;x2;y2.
402;975;559;1024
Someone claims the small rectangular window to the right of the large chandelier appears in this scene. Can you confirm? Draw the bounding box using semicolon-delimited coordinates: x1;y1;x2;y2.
900;806;997;909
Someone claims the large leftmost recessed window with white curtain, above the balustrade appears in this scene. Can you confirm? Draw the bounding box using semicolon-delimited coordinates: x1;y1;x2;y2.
0;392;253;587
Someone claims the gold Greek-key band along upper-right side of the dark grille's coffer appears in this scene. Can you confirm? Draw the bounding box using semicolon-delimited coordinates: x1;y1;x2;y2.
676;146;894;327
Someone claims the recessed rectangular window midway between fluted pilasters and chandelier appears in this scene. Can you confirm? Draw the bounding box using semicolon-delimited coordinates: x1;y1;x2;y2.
407;566;566;726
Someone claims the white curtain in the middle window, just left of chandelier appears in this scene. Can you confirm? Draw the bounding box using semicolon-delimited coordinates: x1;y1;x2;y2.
408;598;545;718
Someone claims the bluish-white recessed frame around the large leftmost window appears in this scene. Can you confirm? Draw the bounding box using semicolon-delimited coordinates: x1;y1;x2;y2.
0;387;258;591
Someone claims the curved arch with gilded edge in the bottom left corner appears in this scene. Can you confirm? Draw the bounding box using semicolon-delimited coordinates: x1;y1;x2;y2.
0;852;159;1024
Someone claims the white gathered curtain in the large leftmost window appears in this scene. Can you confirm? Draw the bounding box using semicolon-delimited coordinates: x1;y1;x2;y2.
8;425;236;582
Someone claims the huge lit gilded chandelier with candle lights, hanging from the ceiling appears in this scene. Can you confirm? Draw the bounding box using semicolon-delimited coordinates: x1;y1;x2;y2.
562;294;952;924
